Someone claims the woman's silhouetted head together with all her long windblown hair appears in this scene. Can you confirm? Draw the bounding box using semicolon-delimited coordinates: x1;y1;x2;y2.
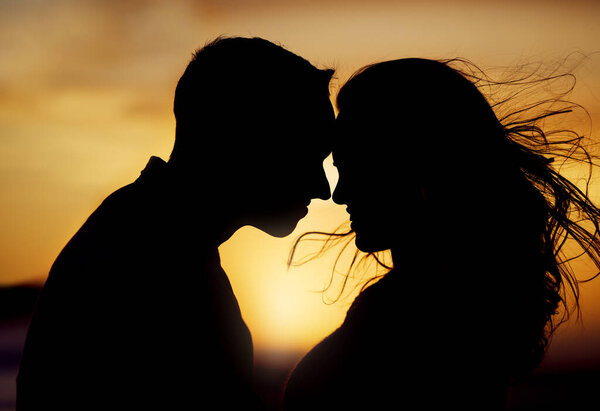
333;59;600;376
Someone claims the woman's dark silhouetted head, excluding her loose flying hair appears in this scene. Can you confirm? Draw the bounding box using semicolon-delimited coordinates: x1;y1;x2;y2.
333;58;504;251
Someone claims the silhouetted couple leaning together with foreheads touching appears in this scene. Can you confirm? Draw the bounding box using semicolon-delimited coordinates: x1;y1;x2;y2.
17;37;600;411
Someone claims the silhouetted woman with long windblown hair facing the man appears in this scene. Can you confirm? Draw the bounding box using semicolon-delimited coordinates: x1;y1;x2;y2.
284;59;600;410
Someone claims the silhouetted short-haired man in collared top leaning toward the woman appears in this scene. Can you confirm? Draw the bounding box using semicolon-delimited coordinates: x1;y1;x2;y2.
17;38;334;411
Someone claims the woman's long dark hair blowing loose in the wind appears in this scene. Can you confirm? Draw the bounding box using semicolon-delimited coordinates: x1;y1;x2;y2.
288;54;600;378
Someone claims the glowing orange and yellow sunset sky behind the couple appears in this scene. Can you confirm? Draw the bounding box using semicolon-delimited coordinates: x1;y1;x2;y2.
0;0;600;364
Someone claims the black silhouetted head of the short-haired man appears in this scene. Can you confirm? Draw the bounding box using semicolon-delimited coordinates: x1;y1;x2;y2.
169;37;334;236
